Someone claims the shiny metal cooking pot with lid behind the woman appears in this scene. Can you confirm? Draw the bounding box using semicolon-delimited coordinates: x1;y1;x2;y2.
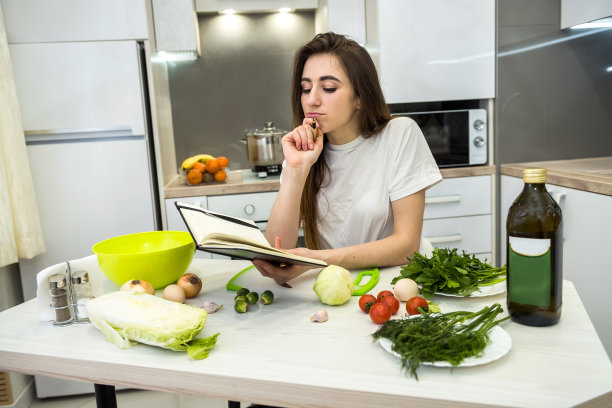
242;122;288;175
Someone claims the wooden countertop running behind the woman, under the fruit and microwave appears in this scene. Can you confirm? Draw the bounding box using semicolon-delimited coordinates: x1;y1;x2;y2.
164;166;495;198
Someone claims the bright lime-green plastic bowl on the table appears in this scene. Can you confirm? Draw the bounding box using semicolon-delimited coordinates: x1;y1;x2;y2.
92;231;195;289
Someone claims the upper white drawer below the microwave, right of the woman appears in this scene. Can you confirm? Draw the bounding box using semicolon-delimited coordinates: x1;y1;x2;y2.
423;176;491;220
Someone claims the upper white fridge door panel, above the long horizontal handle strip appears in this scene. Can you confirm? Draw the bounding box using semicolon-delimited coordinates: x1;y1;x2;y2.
9;41;145;135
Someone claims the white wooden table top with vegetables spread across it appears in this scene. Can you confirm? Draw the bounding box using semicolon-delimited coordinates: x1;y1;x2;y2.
0;259;612;408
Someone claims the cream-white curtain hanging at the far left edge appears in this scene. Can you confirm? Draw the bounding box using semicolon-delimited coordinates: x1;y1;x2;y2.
0;4;45;267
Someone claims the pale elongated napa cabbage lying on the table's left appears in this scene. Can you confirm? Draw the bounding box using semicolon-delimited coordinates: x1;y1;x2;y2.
86;291;219;359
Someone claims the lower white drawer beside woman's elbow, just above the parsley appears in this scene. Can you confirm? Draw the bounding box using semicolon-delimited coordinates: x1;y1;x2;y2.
421;215;491;254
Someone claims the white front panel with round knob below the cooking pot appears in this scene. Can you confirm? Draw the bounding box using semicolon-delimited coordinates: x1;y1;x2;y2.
208;191;278;222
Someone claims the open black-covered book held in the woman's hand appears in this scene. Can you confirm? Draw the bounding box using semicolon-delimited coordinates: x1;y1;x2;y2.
174;202;327;266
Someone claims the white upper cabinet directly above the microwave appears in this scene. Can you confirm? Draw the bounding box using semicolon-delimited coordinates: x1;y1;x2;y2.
366;0;495;103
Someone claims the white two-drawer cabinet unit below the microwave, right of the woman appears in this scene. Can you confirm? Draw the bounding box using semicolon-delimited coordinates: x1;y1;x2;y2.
421;175;495;264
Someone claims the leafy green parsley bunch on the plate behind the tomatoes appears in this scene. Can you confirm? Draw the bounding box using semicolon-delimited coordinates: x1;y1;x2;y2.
391;248;506;298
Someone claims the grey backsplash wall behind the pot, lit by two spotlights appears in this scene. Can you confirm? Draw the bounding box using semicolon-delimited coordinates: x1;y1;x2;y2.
168;11;315;169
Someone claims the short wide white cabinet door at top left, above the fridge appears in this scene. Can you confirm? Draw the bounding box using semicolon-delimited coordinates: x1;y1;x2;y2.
2;0;149;44
